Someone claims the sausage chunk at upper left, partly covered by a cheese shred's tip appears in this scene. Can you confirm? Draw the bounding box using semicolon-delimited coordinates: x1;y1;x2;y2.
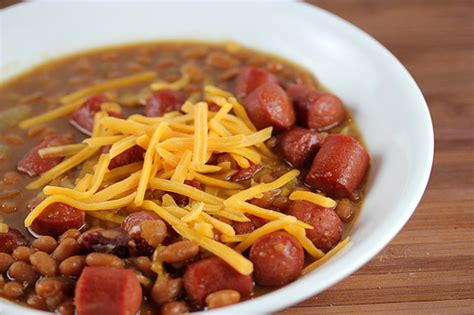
17;135;69;176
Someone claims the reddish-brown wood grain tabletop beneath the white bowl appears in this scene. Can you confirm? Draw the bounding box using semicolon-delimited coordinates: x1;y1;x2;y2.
0;0;474;315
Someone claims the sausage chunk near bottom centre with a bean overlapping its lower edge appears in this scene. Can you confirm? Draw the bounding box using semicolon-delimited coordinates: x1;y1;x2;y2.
183;256;253;308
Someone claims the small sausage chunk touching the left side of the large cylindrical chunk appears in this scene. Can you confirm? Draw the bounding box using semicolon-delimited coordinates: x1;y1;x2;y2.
277;127;324;168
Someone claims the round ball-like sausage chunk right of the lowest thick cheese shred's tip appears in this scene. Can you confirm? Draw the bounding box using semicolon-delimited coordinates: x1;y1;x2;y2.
249;231;304;286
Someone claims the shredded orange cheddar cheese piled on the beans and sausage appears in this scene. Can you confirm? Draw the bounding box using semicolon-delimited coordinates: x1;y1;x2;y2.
22;74;336;275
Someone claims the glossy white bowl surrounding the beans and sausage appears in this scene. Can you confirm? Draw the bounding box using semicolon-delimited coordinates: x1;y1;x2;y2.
0;2;433;314
